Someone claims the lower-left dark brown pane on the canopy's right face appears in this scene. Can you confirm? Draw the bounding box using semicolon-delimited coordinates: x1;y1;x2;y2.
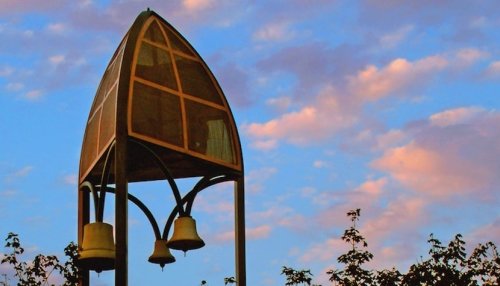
132;82;183;147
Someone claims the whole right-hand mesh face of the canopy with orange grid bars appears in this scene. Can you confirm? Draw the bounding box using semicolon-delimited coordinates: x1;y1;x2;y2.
129;17;239;168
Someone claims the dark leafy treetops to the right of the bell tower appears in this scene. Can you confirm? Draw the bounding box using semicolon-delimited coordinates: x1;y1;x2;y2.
282;209;500;286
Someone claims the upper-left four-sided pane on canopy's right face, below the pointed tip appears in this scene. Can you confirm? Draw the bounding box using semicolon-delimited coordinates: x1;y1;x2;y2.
135;42;177;89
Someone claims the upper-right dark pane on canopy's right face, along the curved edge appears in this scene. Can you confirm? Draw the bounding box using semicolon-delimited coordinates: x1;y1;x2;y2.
175;56;222;105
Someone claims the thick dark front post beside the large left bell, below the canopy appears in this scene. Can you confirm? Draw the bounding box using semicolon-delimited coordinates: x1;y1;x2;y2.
114;136;128;286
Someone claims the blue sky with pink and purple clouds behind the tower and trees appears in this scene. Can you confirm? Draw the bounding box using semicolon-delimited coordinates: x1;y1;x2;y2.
0;0;500;286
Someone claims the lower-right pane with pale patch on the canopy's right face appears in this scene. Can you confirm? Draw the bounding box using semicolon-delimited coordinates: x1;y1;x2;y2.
186;100;235;164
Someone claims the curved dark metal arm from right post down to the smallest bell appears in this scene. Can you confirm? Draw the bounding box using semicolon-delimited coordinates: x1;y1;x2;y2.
161;175;234;240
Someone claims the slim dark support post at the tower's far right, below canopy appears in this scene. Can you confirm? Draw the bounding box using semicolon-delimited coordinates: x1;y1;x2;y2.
234;175;247;286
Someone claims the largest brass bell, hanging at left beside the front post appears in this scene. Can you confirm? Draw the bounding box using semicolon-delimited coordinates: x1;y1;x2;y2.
78;222;115;273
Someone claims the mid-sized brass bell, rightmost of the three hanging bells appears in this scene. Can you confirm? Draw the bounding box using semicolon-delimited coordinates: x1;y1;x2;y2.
167;216;205;252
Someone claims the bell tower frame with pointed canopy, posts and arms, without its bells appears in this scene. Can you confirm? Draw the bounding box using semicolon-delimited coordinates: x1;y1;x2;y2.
78;9;246;286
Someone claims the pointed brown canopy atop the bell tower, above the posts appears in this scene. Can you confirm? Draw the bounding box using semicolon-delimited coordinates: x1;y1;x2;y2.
79;10;243;182
